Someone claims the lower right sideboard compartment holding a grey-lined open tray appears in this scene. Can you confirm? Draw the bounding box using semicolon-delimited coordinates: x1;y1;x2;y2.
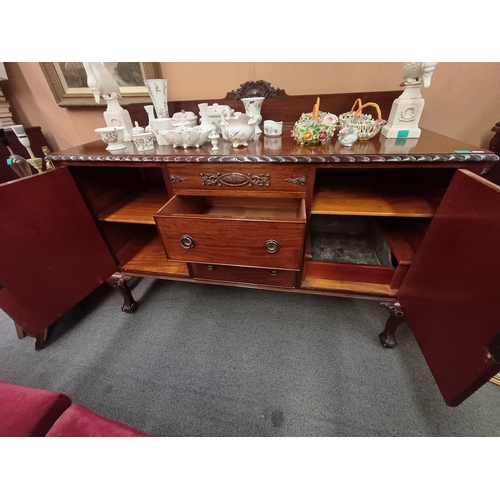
305;215;430;294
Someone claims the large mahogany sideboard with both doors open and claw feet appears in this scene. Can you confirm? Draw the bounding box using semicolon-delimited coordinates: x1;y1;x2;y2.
0;87;500;406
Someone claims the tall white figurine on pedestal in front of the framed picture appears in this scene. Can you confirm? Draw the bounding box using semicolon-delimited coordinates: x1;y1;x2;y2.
66;62;133;141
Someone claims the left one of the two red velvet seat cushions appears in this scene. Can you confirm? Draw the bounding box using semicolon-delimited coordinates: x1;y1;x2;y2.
0;381;71;437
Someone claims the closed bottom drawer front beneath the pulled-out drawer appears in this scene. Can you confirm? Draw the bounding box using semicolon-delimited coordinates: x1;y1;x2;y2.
192;264;297;288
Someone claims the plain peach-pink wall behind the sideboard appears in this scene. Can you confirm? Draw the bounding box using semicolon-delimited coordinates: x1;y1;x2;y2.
2;62;500;150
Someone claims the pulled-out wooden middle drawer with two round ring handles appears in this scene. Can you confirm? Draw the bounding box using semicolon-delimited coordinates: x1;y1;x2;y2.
155;196;306;270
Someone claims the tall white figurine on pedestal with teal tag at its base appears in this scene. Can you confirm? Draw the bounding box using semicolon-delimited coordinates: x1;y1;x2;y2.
380;62;437;139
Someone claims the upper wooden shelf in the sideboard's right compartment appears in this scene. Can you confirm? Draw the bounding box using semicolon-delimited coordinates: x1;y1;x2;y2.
311;184;440;217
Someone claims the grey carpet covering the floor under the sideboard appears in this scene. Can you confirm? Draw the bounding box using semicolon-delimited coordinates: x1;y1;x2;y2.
0;279;500;436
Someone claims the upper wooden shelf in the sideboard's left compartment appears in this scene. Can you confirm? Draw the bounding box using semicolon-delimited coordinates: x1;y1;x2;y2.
99;189;168;225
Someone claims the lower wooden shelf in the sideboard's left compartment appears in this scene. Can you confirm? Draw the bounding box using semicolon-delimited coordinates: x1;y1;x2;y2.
121;236;189;278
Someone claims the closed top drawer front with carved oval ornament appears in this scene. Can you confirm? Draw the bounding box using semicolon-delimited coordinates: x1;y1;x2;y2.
168;163;308;196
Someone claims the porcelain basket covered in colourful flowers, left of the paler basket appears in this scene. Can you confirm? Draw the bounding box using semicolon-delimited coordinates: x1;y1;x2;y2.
292;97;338;146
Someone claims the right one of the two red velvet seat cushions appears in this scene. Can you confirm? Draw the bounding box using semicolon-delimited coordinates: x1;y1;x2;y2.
47;403;151;437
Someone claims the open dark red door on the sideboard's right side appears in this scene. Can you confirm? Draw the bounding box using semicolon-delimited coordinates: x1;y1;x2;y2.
398;170;500;406
